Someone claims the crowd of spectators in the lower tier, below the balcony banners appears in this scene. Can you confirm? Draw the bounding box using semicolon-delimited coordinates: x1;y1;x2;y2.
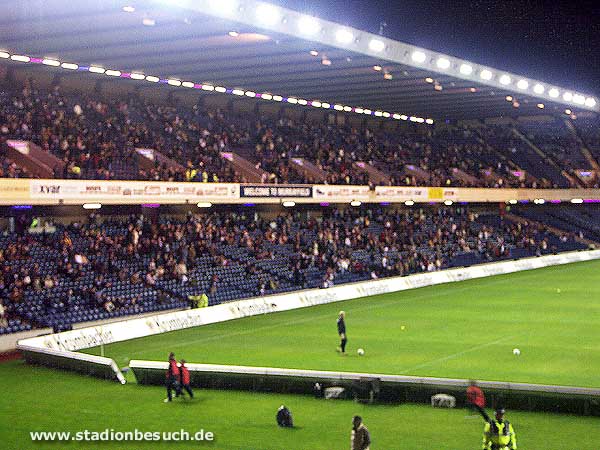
0;207;573;332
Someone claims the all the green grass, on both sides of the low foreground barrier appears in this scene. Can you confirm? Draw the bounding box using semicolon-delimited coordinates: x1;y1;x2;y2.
0;262;600;450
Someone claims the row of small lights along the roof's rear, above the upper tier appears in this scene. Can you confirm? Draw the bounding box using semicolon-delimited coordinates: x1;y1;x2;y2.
0;51;433;125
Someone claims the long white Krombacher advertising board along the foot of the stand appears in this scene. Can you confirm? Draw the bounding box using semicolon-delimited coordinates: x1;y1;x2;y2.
17;250;600;352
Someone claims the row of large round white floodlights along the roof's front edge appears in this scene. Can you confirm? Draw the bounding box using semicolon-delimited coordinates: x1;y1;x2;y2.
156;0;597;108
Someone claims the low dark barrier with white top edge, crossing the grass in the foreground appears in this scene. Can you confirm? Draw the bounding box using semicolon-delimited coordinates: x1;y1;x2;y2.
129;360;600;416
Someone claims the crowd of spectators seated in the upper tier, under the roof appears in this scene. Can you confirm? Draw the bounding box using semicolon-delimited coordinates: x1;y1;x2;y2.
0;80;592;187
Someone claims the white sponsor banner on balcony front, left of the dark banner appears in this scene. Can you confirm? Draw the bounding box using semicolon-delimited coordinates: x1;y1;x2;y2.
30;180;239;203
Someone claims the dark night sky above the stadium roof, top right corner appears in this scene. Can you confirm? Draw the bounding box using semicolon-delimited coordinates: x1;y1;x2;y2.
269;0;600;95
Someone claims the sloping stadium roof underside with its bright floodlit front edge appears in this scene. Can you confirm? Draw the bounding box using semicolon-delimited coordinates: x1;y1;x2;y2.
0;0;600;120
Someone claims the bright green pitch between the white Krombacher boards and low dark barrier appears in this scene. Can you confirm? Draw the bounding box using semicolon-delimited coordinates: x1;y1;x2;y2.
88;261;600;387
